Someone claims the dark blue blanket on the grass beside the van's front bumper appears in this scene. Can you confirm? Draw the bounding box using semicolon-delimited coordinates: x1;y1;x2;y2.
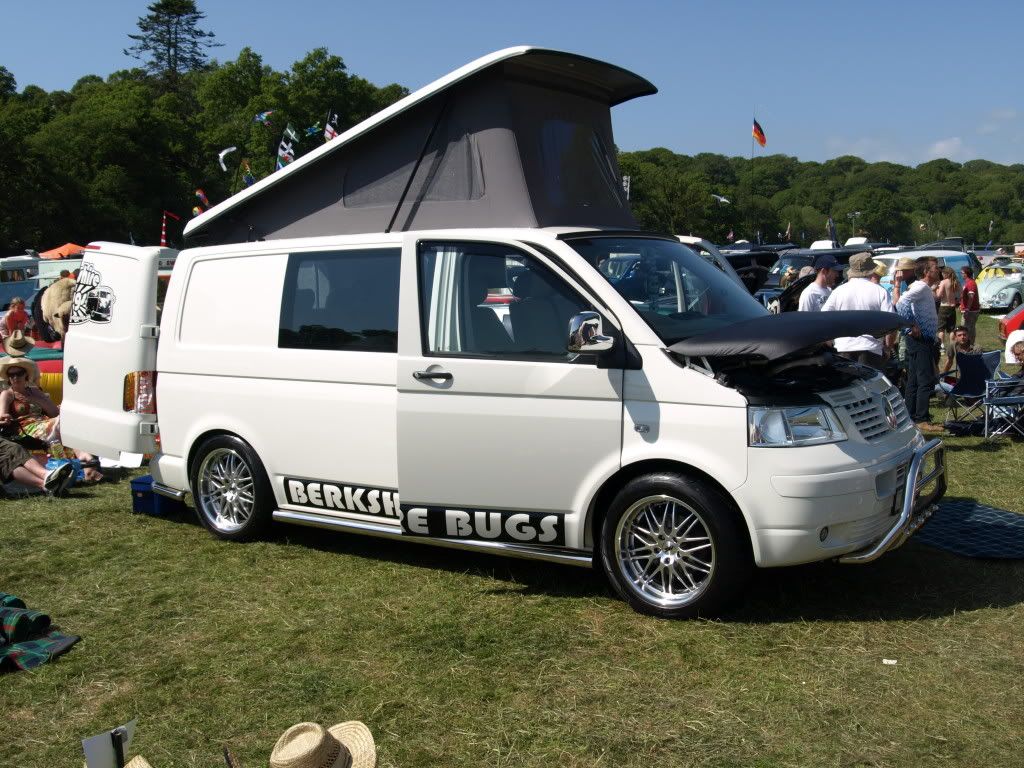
911;499;1024;559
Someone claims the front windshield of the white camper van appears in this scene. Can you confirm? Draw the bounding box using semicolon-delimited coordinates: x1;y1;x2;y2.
566;236;768;345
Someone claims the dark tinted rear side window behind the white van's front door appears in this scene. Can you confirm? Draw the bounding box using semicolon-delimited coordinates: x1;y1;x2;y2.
278;248;401;352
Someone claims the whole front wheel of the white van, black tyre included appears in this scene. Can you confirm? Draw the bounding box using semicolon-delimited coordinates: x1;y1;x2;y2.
600;473;753;618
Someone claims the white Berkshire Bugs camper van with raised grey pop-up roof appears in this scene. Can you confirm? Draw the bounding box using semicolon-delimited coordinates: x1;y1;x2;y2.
61;48;945;617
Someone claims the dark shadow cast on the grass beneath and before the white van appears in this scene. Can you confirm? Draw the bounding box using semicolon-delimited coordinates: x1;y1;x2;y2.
134;498;1024;624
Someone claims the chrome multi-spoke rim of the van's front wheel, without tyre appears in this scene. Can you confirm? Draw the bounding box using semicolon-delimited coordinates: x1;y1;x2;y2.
615;496;715;608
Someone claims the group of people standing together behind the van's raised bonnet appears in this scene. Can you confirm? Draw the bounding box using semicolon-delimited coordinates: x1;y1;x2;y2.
799;252;1024;433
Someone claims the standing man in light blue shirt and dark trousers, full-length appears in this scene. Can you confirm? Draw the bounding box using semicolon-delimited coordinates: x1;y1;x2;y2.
893;256;942;433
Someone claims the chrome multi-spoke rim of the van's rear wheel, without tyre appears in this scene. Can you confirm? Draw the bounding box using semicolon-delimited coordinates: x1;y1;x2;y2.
196;449;256;534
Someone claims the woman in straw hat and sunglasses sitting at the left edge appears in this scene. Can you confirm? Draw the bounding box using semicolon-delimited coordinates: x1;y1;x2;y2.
0;357;102;482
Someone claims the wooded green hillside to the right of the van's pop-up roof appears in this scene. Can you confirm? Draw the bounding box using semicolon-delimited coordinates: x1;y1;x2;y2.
618;147;1024;245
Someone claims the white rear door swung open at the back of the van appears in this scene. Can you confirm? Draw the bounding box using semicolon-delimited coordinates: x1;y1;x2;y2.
60;243;169;466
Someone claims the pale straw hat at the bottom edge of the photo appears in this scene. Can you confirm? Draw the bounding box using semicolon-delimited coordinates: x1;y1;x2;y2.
270;720;377;768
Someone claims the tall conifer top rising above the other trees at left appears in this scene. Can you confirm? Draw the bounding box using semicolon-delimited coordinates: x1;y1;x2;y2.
125;0;220;84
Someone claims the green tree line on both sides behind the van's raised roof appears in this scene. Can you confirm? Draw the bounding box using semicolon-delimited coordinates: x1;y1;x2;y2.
0;0;1024;255
